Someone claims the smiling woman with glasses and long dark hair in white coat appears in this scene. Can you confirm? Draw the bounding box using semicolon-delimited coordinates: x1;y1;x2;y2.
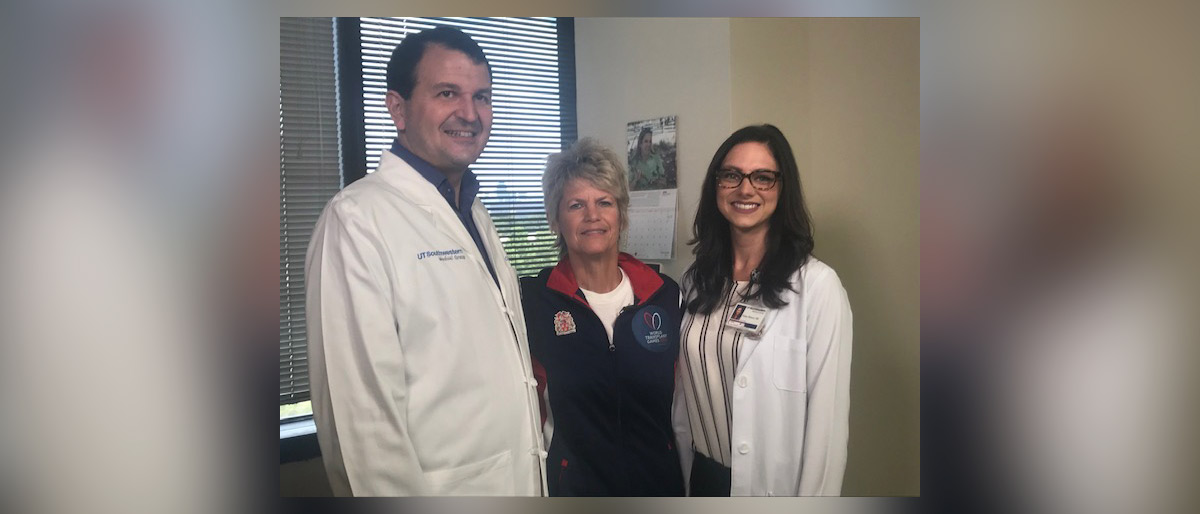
673;125;852;496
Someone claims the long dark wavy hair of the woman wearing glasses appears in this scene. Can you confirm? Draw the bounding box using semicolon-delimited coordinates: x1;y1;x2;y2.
684;125;812;313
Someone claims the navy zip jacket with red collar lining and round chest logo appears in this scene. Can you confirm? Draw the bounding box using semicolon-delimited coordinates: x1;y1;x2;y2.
521;253;684;496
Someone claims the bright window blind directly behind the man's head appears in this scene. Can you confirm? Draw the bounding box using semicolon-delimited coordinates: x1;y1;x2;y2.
360;18;563;275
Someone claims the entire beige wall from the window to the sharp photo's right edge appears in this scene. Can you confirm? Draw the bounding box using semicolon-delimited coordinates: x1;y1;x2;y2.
576;18;920;495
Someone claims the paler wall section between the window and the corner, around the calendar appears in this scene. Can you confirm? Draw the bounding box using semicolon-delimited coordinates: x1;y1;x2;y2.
575;18;730;279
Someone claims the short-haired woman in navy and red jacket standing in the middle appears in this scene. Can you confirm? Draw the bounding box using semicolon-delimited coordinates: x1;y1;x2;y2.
521;139;684;496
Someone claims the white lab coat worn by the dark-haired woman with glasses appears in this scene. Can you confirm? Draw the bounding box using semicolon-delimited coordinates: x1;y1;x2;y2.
673;257;852;496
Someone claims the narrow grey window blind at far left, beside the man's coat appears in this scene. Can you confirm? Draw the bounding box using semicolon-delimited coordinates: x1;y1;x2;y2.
280;18;342;405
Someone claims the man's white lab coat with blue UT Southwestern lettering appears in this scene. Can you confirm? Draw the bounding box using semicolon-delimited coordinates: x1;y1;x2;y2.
305;151;545;496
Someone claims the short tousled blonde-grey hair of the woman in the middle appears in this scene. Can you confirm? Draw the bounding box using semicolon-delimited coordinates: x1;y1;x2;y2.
541;137;629;257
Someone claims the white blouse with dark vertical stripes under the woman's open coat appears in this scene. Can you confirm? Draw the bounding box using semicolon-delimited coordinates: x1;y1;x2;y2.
680;281;749;467
